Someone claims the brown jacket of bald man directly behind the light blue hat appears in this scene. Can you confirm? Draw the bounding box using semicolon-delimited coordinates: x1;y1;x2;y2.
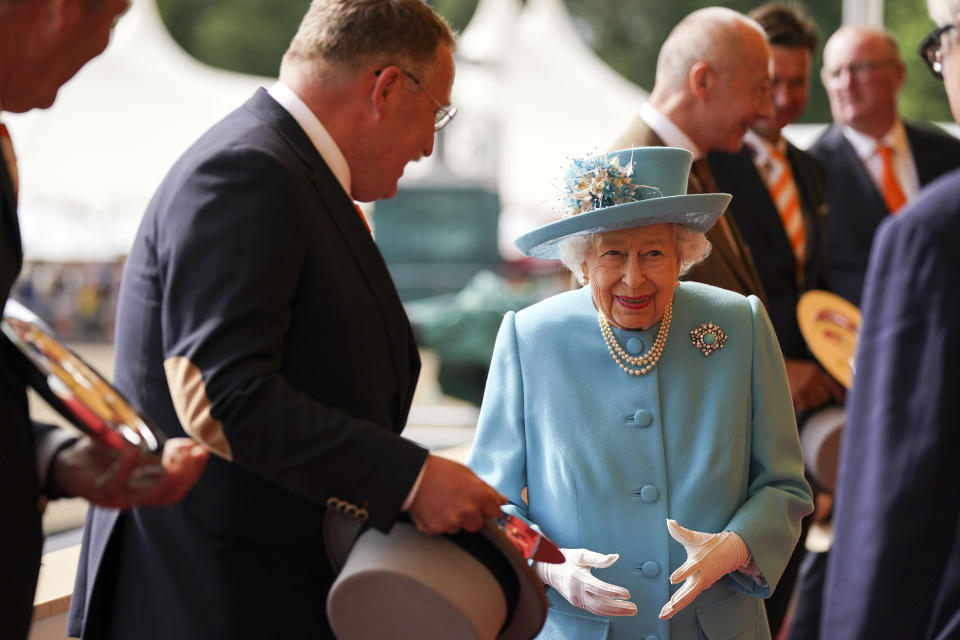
611;116;767;304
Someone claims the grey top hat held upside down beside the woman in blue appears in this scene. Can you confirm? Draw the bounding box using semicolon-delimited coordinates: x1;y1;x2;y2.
324;509;547;640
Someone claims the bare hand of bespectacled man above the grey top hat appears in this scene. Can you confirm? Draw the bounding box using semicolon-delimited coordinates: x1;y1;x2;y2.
407;454;507;534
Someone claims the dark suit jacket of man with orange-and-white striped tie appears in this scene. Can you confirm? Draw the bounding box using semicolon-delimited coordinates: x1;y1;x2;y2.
707;144;827;359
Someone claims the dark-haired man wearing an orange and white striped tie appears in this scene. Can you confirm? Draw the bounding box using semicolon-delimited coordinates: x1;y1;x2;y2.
707;3;843;636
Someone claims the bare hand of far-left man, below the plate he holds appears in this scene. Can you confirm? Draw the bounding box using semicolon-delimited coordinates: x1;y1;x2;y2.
52;437;209;509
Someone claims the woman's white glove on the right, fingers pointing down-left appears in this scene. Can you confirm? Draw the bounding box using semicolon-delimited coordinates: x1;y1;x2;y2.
660;519;751;620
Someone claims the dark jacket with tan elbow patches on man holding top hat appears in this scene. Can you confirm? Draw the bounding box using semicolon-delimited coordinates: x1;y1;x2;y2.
70;90;427;640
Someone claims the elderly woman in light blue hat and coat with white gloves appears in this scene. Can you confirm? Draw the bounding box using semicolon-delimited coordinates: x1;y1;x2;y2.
468;147;812;640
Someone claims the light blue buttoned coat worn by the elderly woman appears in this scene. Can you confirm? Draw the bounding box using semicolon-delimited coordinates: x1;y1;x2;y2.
468;282;812;640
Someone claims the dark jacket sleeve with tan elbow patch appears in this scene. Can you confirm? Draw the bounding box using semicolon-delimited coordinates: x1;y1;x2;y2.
155;148;426;528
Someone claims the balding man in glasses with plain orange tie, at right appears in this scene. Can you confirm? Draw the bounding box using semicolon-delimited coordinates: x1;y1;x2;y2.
810;27;960;305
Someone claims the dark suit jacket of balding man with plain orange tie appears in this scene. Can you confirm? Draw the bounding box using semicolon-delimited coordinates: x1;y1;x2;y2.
809;124;960;306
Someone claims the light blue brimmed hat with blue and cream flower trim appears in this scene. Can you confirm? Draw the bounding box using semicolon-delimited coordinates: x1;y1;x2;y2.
514;147;731;259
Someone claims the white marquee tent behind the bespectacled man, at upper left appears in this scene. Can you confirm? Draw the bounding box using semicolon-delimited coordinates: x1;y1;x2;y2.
5;0;270;261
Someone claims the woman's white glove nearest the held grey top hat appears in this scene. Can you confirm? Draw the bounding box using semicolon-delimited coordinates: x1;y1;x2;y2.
533;549;637;616
